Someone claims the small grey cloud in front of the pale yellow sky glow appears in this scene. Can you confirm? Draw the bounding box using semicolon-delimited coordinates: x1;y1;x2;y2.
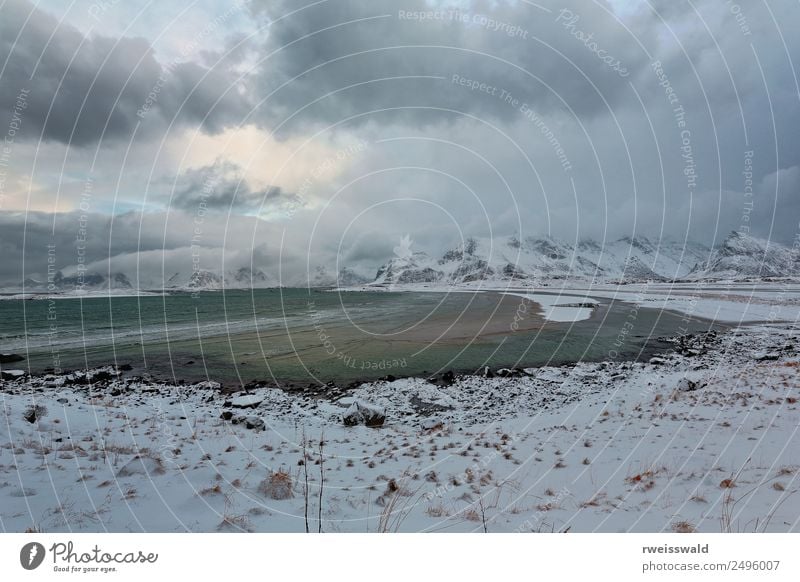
169;161;303;213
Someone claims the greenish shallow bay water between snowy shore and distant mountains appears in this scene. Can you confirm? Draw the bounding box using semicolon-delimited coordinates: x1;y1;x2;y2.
0;289;720;385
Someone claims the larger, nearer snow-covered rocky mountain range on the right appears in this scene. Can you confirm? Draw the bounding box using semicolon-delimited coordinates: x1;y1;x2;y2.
373;232;800;286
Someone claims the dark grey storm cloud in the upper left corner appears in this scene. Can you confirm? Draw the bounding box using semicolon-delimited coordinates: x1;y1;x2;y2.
0;0;247;145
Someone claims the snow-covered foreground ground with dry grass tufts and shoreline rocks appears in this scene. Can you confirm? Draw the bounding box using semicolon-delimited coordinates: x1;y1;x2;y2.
0;324;800;532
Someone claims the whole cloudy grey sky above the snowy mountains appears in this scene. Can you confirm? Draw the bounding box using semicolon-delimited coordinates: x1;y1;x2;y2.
0;0;800;286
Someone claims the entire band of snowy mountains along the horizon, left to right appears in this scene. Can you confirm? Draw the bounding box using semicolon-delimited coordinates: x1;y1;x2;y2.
9;232;800;292
